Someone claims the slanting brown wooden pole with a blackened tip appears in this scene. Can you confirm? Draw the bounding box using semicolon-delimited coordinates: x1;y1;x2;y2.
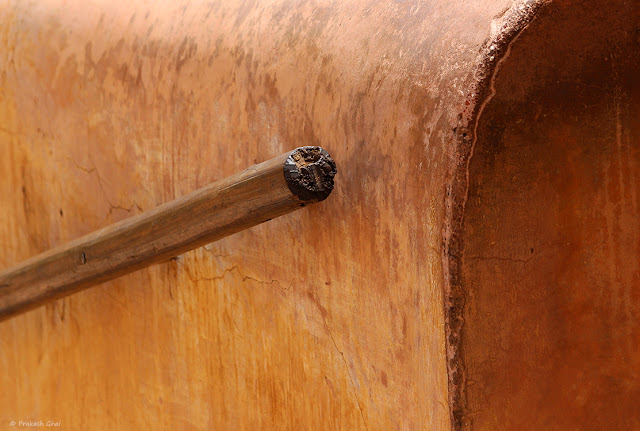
0;147;336;320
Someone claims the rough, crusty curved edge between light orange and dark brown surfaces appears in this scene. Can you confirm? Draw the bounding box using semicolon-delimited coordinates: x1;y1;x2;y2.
442;0;553;431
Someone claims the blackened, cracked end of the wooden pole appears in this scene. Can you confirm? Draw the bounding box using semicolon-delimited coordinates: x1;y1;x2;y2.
284;147;337;202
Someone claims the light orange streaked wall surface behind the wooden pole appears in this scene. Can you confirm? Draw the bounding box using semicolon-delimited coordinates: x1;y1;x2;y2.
0;0;510;430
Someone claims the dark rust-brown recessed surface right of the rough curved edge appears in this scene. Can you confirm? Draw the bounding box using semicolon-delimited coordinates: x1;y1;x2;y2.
460;1;640;430
